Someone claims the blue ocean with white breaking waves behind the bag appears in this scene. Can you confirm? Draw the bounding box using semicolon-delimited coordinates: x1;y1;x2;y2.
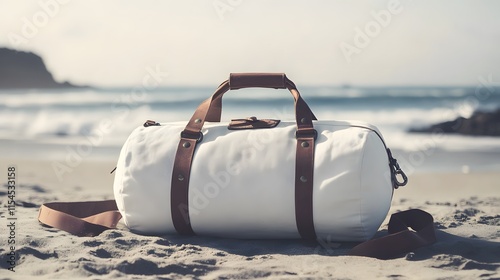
0;86;500;172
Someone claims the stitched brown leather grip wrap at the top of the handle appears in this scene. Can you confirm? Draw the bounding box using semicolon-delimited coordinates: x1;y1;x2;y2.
229;73;286;89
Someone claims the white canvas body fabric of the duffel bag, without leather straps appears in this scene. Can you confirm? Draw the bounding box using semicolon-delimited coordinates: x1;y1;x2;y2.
114;121;393;241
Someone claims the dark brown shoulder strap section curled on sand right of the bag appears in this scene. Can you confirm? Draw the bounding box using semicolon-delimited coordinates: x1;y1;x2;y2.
349;209;436;259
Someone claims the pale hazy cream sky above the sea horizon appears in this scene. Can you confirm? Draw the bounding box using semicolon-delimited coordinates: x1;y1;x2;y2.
0;0;500;87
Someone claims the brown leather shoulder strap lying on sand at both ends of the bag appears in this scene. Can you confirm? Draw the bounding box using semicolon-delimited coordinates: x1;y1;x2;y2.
38;200;436;259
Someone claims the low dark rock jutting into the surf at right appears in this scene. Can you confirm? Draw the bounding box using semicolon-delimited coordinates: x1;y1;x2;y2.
409;109;500;136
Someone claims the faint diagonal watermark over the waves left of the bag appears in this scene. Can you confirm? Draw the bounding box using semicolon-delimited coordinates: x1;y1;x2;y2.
52;65;169;181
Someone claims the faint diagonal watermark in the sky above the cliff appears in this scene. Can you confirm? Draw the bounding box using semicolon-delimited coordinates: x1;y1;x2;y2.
7;0;70;47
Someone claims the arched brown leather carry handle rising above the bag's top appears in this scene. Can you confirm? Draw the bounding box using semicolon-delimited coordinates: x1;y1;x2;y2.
205;73;317;122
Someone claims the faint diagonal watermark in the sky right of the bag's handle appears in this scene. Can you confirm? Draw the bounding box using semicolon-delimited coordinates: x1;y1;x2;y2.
339;0;403;63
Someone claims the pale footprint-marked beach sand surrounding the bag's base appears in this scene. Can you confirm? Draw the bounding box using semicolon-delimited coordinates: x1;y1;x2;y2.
0;159;500;279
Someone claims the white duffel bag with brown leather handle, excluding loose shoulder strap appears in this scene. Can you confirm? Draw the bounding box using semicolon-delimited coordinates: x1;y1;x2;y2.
114;73;406;241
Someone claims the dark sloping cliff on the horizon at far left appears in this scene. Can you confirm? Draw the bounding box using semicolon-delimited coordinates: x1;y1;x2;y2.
0;48;79;89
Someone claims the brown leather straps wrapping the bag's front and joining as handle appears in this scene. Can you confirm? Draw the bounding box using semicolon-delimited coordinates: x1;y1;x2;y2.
170;74;316;239
